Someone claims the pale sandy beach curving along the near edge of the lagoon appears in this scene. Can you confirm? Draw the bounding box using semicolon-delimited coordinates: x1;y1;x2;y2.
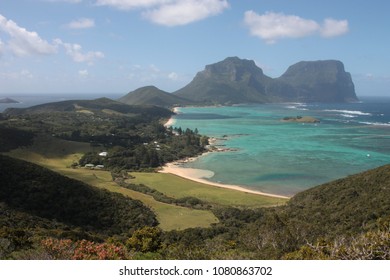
158;160;291;199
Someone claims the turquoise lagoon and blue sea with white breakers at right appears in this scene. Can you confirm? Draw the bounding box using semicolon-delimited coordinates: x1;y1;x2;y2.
173;97;390;195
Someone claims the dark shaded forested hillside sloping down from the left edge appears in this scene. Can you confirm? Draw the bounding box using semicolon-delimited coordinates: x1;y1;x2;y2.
0;155;157;236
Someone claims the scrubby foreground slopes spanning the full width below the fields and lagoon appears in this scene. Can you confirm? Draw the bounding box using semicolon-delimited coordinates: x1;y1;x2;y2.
0;151;390;259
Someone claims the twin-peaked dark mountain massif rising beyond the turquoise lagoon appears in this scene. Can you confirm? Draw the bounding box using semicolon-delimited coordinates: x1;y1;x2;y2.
174;57;358;105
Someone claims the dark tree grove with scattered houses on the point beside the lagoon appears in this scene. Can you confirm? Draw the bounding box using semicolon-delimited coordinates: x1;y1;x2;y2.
80;126;208;170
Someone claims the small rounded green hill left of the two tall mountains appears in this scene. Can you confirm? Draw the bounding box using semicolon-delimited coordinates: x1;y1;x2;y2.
118;86;193;107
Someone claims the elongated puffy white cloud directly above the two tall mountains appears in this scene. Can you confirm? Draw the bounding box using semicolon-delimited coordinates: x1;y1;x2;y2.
244;11;348;44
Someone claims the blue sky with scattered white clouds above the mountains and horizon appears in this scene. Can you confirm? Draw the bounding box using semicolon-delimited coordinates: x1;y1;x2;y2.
0;0;390;97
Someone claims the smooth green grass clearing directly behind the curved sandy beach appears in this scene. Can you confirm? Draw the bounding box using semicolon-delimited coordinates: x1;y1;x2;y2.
128;172;287;208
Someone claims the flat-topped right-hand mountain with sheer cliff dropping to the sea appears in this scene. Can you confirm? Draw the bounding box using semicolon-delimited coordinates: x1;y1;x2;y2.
275;60;358;103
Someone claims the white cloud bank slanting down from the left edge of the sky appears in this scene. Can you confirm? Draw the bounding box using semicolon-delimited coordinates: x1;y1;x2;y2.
0;15;57;56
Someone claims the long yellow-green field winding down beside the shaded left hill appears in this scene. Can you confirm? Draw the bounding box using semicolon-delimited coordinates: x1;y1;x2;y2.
7;135;218;230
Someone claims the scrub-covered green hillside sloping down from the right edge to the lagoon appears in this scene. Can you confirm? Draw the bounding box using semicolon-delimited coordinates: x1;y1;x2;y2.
283;165;390;237
